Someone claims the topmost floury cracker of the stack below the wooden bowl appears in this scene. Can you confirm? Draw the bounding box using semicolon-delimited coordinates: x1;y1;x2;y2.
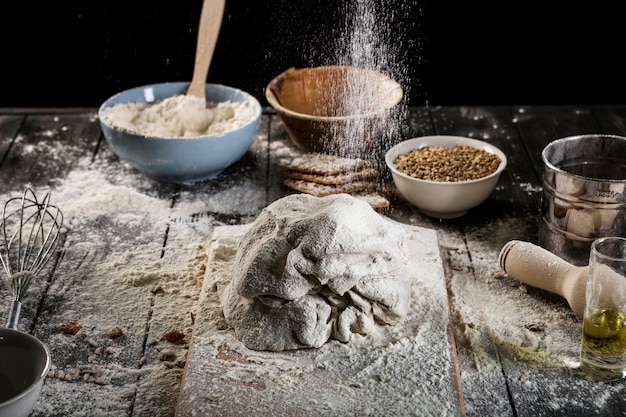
276;153;372;175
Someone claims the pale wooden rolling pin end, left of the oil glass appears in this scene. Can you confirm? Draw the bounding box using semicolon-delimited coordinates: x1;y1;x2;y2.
498;240;588;317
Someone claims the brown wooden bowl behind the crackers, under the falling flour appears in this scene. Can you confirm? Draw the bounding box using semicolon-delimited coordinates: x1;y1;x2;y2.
265;66;402;156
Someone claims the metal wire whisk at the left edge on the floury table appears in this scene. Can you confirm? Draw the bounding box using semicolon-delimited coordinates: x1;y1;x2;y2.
0;188;63;329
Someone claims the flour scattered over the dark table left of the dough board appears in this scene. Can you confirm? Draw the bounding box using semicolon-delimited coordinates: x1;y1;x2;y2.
0;158;232;416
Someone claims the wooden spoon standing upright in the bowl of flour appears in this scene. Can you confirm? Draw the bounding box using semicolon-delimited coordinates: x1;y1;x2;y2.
180;0;226;133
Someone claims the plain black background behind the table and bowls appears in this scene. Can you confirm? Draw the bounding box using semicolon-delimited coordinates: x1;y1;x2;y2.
0;0;626;107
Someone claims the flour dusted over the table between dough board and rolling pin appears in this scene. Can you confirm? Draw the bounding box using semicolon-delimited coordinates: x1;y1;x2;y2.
439;213;626;415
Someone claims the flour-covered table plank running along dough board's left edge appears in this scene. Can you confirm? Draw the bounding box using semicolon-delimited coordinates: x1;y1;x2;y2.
133;110;269;416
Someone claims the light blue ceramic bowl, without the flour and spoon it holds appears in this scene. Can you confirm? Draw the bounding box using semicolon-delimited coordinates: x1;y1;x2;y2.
98;82;261;183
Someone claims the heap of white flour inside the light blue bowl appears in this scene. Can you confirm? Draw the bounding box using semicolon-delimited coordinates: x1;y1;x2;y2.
102;95;254;138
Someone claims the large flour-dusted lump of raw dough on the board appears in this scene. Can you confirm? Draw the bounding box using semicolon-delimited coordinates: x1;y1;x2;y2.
220;194;411;351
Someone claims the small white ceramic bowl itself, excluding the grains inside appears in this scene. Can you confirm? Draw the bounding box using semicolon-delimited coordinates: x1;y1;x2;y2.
385;135;507;219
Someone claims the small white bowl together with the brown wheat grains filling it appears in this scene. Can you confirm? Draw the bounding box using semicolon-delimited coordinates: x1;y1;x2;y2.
385;135;507;219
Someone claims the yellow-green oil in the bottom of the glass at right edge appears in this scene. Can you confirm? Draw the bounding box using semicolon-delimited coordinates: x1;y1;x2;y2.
580;308;626;381
